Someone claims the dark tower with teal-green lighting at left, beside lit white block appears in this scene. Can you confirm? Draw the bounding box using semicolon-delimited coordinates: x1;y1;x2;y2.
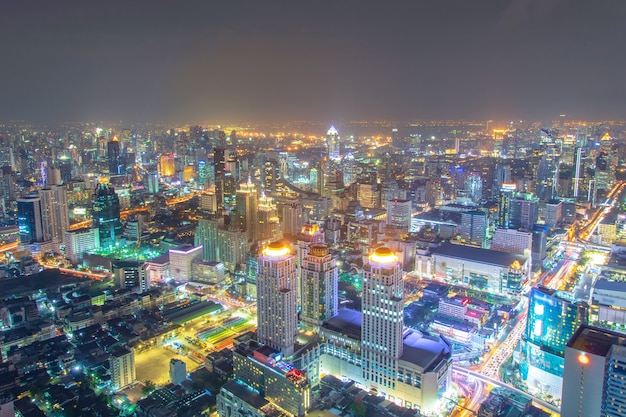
91;183;122;248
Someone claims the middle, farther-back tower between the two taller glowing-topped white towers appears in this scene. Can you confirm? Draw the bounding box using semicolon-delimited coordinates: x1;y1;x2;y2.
300;243;339;328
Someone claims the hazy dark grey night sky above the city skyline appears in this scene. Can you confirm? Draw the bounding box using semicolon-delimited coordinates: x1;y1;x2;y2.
0;0;626;122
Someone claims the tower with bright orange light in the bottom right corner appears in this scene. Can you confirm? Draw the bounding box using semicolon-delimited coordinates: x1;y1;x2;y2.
561;326;626;417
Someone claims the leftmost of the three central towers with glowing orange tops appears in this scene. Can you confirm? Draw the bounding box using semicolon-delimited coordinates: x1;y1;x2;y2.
257;242;298;356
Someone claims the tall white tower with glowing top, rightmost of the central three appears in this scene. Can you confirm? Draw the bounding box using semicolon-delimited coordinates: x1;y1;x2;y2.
361;247;404;392
